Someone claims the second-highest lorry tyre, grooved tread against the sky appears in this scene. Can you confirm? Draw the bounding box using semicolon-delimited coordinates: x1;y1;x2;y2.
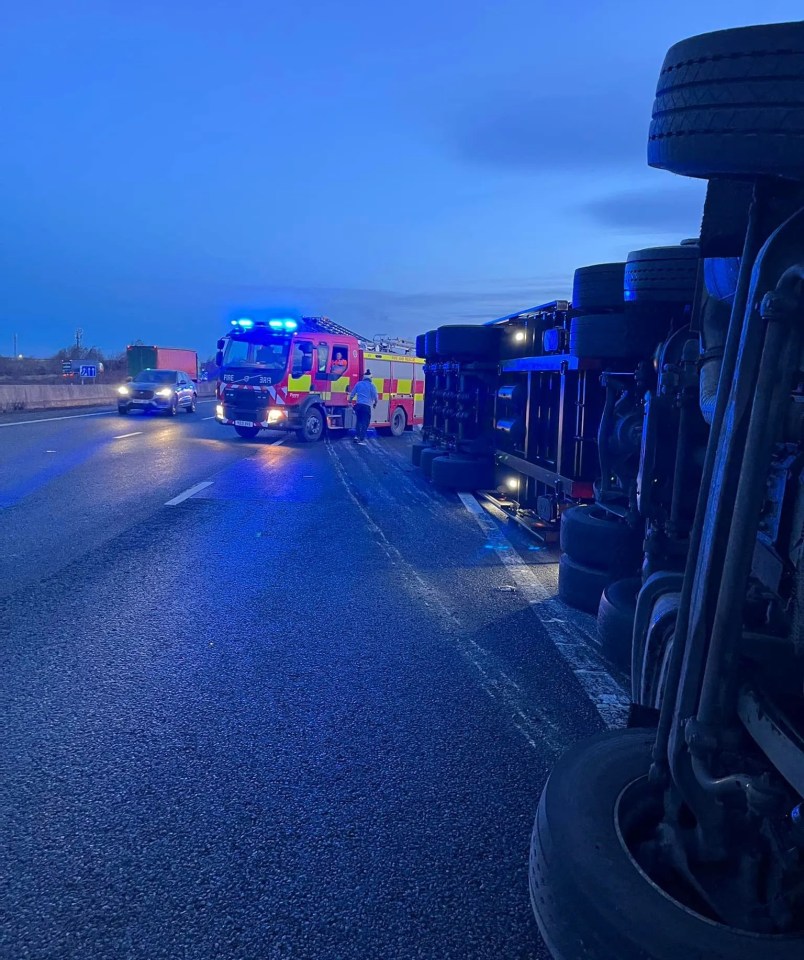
625;243;700;305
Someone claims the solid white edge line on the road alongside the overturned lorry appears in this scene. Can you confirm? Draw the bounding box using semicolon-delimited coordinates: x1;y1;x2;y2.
458;493;630;727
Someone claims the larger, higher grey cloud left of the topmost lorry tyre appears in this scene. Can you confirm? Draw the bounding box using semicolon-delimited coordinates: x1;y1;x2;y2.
445;81;651;171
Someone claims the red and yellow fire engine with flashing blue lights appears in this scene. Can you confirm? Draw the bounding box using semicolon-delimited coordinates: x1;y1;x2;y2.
215;317;424;442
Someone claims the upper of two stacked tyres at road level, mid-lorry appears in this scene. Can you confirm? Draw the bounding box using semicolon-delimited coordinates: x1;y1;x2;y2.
559;504;642;568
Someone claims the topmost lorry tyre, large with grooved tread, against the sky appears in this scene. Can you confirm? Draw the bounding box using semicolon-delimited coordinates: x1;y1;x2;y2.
648;21;804;180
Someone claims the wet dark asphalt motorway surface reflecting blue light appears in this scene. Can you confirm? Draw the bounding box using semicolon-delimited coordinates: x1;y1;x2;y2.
0;403;616;960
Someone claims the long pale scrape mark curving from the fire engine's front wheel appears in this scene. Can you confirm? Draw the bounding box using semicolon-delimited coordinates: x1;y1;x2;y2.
327;444;566;754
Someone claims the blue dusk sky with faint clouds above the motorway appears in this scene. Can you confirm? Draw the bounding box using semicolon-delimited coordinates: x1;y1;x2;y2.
0;0;801;356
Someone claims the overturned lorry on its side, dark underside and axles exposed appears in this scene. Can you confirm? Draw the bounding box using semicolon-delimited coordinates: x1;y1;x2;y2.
418;16;804;960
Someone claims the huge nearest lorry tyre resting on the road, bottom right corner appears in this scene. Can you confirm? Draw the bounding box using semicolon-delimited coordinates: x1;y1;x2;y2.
529;729;804;960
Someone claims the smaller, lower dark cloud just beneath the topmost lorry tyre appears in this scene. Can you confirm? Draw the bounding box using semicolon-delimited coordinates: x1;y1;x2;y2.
579;182;704;237
